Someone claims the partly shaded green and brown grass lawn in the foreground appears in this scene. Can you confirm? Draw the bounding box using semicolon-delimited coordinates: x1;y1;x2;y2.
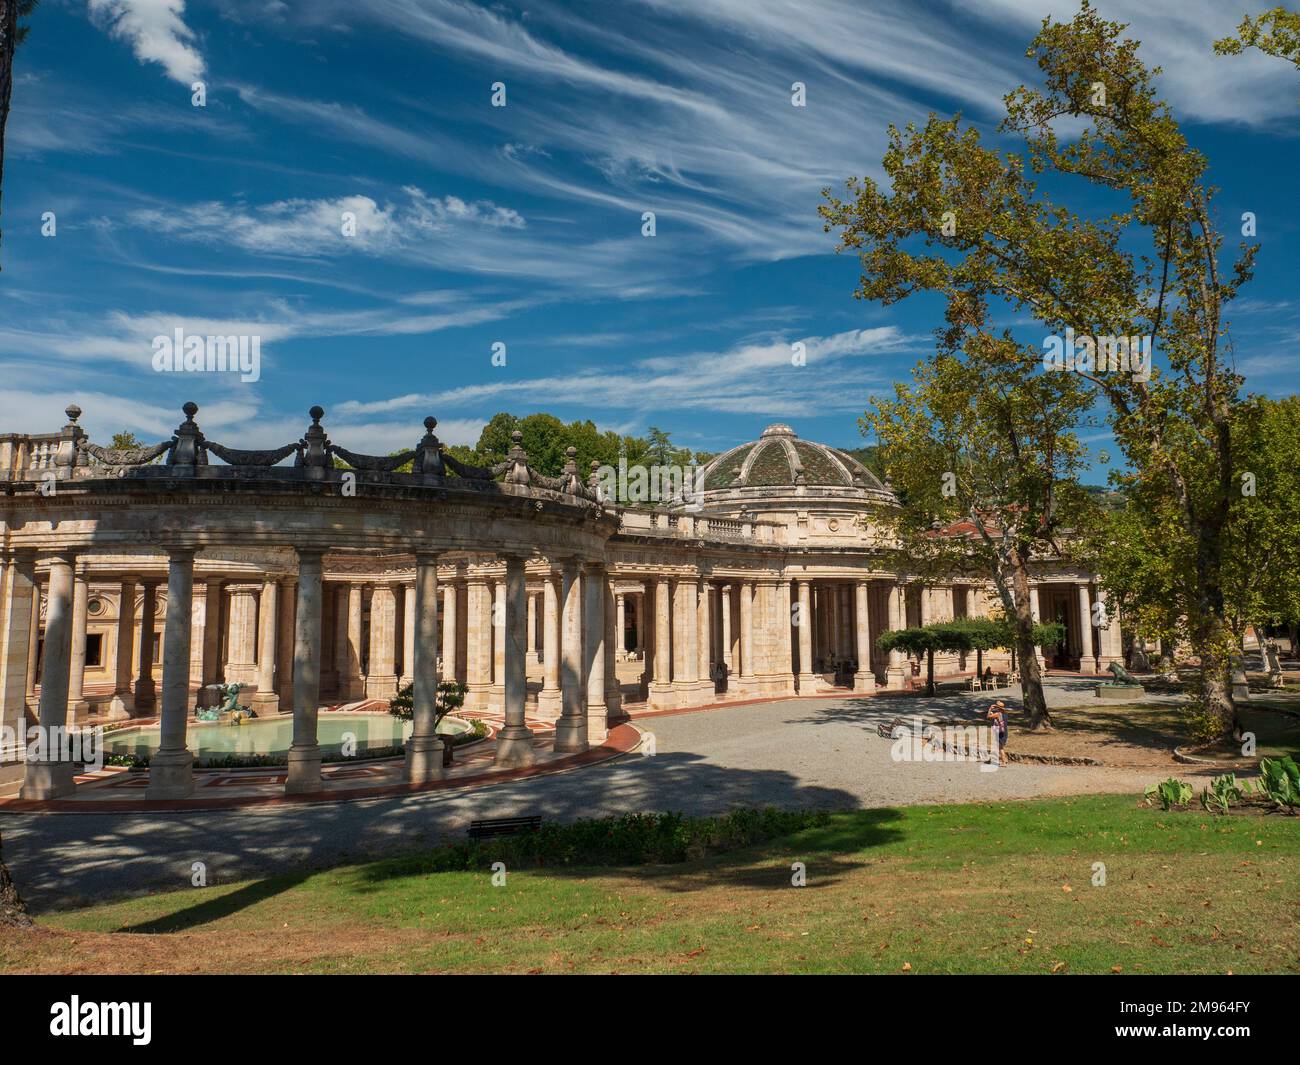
0;796;1300;974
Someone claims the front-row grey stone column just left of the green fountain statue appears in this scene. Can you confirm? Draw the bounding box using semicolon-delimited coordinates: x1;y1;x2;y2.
144;547;194;798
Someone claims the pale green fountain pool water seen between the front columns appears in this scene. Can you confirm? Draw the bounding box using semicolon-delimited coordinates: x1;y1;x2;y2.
104;713;469;759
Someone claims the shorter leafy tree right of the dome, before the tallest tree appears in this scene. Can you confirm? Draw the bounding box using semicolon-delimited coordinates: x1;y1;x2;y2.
862;340;1096;728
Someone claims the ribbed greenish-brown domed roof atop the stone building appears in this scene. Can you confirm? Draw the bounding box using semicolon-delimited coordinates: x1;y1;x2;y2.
699;423;887;493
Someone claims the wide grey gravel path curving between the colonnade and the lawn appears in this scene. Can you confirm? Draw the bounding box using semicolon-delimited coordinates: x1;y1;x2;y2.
0;688;1185;912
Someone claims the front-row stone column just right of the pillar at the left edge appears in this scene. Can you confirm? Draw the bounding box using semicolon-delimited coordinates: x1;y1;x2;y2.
20;551;77;798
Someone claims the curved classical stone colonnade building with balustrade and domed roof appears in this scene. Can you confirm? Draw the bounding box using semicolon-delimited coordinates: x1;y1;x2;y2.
0;404;1122;798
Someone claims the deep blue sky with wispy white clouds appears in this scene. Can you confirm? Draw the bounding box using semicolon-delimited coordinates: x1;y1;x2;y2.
0;0;1300;465
